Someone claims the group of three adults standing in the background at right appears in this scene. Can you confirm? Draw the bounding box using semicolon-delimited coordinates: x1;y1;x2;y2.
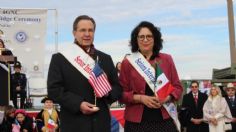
180;81;236;132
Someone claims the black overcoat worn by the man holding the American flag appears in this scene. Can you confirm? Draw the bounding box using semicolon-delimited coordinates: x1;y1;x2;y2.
48;50;122;132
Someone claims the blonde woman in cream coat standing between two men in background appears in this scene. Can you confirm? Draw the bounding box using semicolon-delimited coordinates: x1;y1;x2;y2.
203;85;232;132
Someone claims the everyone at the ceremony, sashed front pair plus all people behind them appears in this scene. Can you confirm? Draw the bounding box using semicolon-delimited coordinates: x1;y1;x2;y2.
0;15;236;132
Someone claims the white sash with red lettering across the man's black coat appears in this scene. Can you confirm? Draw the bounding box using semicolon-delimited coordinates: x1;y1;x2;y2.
59;44;95;79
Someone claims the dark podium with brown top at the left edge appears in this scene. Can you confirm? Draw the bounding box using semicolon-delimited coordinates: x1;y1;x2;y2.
0;55;16;106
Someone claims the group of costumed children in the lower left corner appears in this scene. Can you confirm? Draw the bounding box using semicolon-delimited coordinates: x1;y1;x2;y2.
0;97;60;132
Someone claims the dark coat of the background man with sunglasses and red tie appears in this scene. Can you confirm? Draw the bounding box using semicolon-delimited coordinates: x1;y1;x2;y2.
182;91;209;132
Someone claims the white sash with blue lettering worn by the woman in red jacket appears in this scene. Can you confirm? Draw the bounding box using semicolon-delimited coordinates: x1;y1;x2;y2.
127;52;180;131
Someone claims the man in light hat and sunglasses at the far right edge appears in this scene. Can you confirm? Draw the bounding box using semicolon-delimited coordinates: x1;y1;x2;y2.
225;83;236;132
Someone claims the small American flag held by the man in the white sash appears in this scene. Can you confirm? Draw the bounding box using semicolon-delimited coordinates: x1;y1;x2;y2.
89;63;111;97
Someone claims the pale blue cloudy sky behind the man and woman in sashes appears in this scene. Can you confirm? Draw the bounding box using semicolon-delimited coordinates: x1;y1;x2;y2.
0;0;235;79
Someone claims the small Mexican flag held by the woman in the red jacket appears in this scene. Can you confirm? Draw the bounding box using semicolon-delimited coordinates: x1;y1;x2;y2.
155;65;174;100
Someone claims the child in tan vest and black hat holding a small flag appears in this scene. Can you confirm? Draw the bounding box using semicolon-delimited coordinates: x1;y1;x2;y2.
36;97;59;132
